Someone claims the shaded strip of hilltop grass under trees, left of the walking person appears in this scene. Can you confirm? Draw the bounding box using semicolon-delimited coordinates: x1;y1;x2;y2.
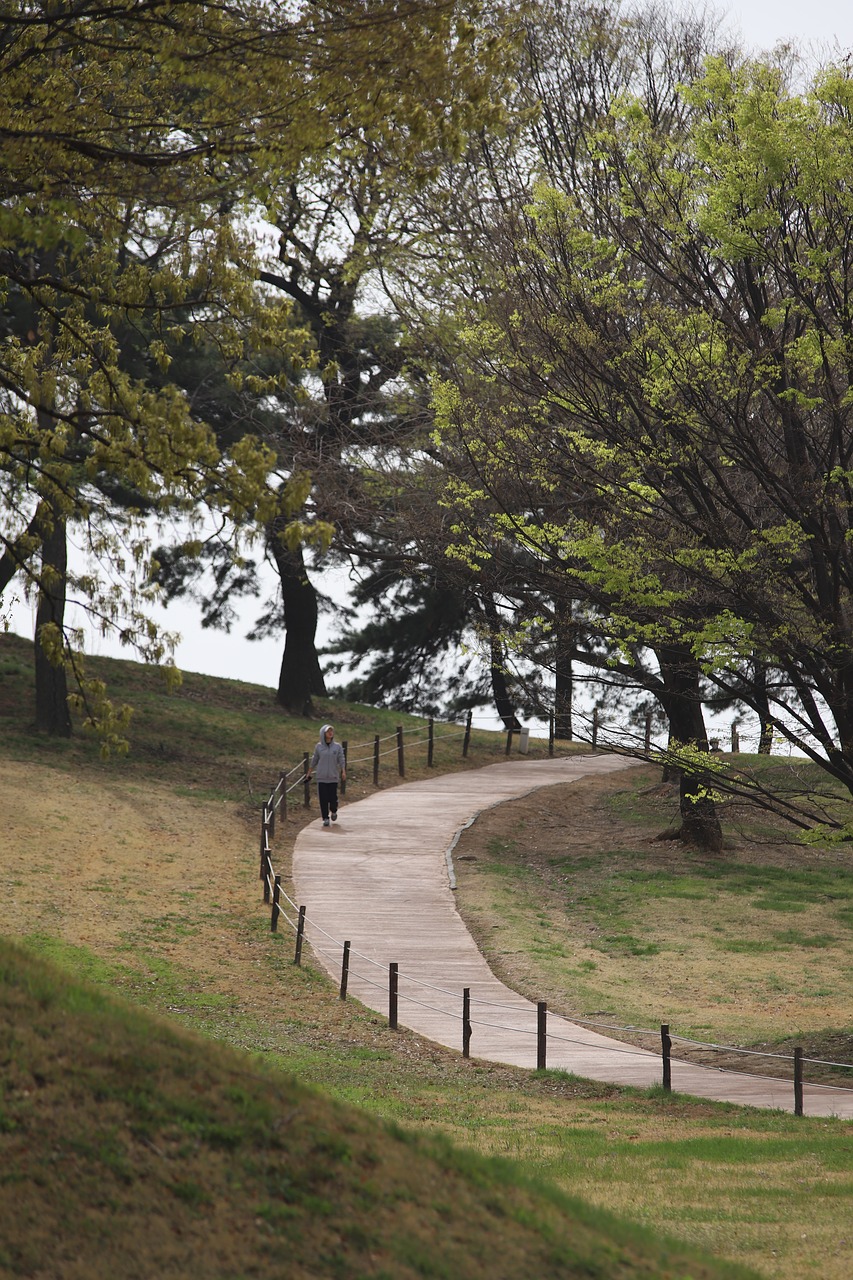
0;634;555;818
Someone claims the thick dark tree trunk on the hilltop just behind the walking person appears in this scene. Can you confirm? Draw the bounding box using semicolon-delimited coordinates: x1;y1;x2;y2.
270;535;325;716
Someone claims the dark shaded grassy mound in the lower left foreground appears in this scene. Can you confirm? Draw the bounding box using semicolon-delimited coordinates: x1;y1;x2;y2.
0;943;747;1280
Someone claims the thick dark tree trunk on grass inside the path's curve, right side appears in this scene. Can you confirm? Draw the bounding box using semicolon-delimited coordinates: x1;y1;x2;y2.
657;645;722;854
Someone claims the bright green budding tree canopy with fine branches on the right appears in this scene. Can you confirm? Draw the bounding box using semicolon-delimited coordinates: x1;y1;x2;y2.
437;40;853;829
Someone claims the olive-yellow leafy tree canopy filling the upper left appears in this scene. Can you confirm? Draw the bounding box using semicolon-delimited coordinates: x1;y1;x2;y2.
0;0;514;739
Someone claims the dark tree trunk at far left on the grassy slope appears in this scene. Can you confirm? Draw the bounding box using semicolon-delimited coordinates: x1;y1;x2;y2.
35;504;72;737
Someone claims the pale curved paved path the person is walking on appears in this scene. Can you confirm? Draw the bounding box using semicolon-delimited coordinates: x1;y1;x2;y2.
293;755;853;1117
